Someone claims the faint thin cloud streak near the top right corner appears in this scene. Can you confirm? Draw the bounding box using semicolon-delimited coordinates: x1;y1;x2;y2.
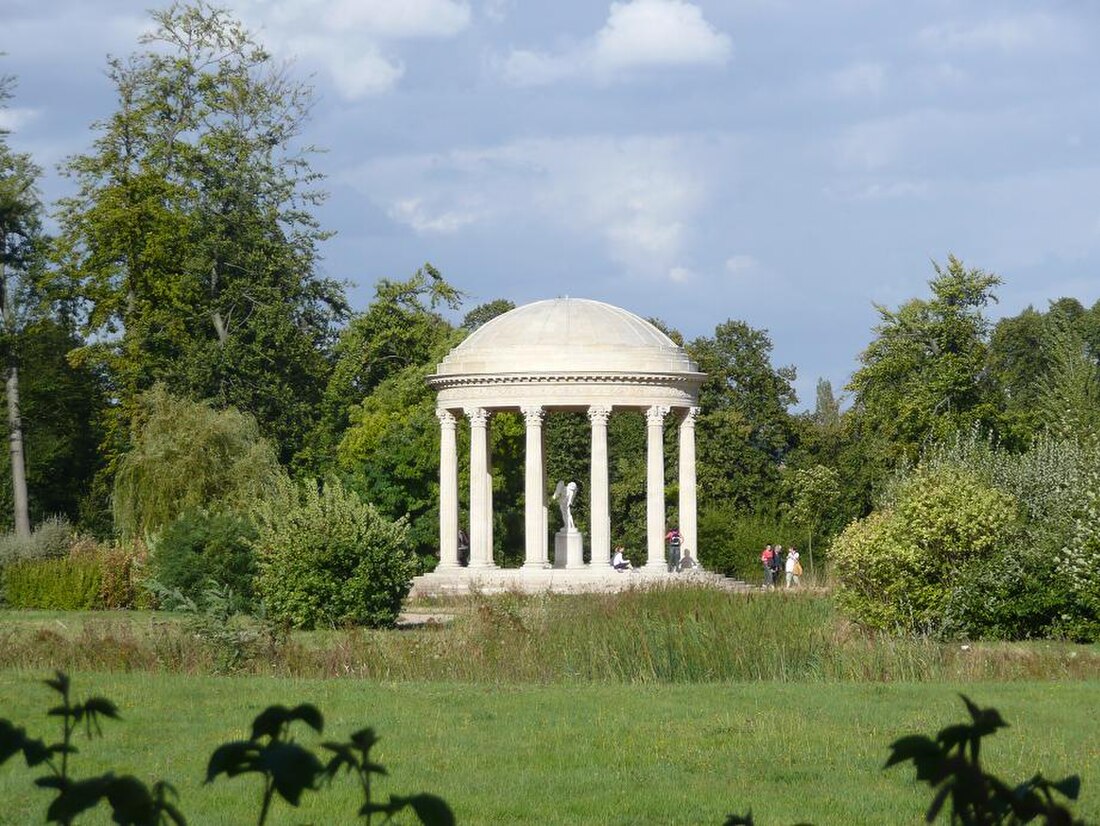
916;12;1078;53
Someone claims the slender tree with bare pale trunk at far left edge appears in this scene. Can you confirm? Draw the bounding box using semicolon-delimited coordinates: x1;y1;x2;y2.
0;76;42;538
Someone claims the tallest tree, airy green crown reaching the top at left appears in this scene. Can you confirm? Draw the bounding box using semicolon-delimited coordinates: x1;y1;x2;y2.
55;0;347;468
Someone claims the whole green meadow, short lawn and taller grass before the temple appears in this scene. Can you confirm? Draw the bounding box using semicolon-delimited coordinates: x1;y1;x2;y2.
0;588;1100;824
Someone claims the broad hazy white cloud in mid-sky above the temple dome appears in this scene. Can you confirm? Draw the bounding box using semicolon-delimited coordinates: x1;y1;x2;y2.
349;136;728;280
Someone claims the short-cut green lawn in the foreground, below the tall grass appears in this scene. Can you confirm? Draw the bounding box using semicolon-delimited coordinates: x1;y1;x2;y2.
0;670;1100;826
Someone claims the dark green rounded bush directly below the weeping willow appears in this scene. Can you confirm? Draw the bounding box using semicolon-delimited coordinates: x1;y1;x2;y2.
151;510;256;604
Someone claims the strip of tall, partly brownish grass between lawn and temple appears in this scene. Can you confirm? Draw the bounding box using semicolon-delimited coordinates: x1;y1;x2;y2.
0;586;1100;684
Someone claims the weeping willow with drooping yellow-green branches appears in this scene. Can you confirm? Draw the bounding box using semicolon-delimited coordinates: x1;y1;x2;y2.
112;385;285;537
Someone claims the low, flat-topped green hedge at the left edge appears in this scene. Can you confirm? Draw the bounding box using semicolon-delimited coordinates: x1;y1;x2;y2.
3;558;103;610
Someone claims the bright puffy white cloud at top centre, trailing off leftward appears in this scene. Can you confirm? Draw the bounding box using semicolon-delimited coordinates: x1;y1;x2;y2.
502;0;733;86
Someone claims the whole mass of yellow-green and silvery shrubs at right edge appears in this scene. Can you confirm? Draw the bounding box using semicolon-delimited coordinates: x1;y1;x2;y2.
832;436;1100;640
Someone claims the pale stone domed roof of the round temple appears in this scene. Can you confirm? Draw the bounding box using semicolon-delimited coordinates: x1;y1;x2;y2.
437;298;697;377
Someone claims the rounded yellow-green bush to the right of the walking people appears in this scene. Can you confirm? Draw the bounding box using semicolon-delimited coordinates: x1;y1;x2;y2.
829;465;1019;634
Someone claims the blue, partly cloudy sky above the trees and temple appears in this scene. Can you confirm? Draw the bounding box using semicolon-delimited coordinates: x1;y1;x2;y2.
0;0;1100;407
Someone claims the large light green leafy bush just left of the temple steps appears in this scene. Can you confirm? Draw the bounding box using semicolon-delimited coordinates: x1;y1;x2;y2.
255;480;415;628
